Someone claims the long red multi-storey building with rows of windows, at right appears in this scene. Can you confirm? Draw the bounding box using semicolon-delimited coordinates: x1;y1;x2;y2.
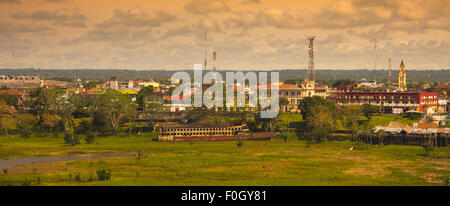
336;86;438;114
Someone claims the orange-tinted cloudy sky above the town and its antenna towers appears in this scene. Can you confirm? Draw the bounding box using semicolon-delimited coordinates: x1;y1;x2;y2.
0;0;450;70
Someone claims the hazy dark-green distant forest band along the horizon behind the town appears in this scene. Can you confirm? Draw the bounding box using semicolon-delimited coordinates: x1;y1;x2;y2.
0;69;450;85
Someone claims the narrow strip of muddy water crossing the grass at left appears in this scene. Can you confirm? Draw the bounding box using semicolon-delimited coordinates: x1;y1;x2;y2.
0;153;136;169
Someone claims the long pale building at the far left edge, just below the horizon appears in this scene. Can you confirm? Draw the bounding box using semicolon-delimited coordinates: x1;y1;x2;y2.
0;75;42;89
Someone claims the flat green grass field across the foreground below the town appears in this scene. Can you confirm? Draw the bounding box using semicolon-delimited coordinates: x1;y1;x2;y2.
0;137;450;185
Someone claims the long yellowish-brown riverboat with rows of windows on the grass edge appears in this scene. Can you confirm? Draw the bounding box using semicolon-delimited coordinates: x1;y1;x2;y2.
158;122;274;141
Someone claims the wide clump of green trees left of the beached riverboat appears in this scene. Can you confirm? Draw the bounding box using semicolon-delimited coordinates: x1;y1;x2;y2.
0;88;153;144
